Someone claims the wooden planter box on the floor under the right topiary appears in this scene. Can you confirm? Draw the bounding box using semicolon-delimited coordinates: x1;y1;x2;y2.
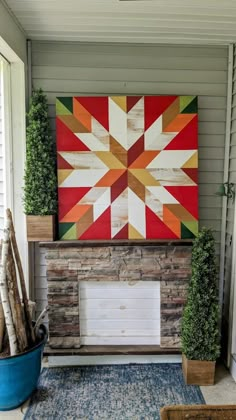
182;354;216;385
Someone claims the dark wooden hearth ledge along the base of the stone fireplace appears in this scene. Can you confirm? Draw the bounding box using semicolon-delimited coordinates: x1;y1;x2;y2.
44;346;181;356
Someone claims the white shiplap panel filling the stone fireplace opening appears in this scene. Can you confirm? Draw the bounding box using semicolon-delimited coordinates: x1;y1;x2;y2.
80;281;160;345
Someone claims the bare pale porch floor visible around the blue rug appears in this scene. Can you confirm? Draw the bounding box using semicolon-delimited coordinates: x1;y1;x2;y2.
0;361;236;420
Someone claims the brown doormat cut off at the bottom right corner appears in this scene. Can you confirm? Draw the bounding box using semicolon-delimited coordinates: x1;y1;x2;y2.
160;405;236;420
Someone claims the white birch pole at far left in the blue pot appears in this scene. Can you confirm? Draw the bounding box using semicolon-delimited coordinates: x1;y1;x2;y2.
0;210;18;356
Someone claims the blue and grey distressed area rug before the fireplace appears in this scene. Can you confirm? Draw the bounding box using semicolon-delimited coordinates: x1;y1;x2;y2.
24;363;205;420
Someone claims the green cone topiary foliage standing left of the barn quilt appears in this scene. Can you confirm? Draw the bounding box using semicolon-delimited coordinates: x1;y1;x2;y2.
24;89;57;215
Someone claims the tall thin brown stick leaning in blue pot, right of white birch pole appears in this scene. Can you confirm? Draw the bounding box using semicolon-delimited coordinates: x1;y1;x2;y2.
7;209;35;345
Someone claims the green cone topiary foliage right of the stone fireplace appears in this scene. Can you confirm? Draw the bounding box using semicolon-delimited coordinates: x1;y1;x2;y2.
182;228;220;361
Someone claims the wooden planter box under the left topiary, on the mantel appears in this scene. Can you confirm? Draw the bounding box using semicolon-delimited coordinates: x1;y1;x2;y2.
26;215;56;242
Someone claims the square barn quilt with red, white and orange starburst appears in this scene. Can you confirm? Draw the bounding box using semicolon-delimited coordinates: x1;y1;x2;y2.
56;96;198;240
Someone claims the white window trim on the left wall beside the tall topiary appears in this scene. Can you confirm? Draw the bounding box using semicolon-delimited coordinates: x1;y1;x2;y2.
0;37;30;293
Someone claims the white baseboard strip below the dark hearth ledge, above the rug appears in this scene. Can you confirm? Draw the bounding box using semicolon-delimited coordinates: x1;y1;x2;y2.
48;355;181;367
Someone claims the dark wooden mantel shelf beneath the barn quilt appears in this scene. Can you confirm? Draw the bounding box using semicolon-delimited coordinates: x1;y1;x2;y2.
39;239;193;249
